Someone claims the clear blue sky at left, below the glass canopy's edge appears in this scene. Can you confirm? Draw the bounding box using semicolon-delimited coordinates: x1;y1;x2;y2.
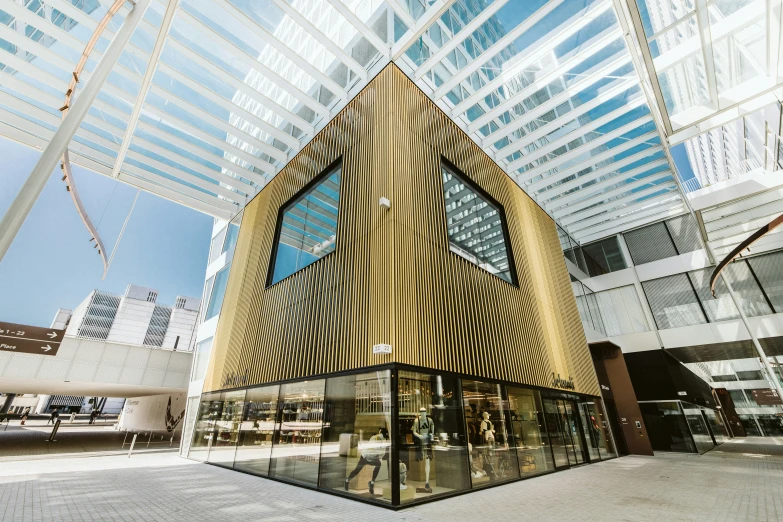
0;138;213;326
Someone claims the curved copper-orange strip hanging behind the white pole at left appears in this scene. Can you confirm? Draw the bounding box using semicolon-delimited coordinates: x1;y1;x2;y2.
60;0;125;277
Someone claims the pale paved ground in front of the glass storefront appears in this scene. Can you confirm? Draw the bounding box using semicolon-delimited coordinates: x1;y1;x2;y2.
0;439;783;522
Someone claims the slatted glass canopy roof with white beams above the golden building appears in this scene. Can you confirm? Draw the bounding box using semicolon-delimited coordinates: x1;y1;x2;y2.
0;0;780;246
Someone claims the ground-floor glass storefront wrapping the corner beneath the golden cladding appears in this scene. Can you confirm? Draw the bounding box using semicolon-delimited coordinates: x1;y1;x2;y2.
188;369;612;505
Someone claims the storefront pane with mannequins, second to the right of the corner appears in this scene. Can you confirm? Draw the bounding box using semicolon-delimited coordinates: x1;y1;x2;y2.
462;380;519;488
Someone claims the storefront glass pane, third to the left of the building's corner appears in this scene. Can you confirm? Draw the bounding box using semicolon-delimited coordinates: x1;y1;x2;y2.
234;386;280;475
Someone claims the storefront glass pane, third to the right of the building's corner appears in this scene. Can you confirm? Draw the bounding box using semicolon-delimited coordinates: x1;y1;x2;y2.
508;387;555;477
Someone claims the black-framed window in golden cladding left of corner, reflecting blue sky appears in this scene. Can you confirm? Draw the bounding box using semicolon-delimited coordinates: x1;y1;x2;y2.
269;164;342;285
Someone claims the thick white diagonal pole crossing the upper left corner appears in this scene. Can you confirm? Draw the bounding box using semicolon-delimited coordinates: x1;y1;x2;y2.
0;0;150;261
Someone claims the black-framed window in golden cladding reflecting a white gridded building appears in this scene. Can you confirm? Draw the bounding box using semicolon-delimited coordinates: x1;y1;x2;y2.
441;165;516;284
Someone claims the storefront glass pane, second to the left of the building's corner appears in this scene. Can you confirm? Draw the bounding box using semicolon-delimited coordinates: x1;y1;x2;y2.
269;380;324;486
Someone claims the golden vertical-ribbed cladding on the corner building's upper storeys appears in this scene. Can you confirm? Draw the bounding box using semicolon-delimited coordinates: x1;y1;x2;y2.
205;65;599;395
